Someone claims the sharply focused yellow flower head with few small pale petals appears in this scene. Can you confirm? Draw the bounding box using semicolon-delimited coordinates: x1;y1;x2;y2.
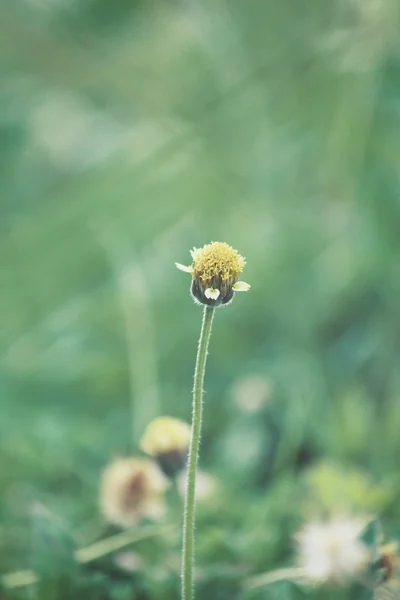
175;242;250;307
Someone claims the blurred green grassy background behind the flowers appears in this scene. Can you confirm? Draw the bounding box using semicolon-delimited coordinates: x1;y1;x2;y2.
0;0;400;600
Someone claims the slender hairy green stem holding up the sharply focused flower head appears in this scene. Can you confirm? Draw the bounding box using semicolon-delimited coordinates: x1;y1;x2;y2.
182;306;214;600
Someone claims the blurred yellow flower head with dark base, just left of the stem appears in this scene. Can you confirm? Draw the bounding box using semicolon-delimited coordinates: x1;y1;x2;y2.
140;417;190;477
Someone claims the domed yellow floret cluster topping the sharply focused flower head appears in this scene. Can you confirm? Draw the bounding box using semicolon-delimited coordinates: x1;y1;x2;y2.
193;242;246;281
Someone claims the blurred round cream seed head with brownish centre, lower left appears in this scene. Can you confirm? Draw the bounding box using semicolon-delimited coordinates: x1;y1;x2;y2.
100;458;168;527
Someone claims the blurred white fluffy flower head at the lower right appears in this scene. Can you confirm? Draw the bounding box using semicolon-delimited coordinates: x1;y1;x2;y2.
296;518;371;584
